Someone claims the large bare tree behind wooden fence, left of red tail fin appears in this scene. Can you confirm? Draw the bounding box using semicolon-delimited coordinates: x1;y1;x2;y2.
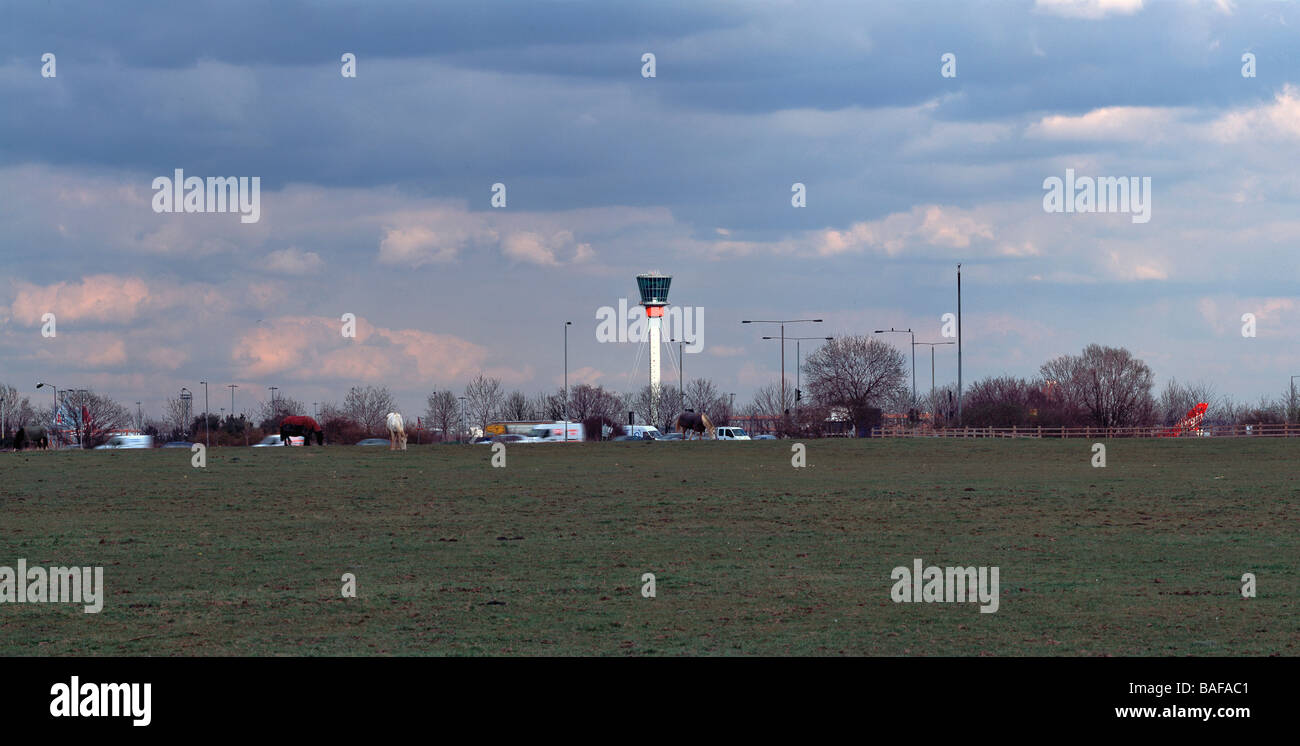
1040;344;1156;428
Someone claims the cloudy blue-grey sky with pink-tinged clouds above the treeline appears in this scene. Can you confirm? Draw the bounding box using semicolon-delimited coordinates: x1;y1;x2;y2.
0;0;1300;416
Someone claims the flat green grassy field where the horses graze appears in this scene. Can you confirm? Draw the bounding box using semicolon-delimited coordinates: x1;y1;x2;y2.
0;438;1300;655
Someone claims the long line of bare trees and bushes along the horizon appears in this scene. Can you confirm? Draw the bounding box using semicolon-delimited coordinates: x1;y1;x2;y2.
0;335;1300;447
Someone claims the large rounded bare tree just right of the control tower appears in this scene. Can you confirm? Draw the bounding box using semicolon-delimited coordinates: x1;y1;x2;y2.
800;335;905;436
